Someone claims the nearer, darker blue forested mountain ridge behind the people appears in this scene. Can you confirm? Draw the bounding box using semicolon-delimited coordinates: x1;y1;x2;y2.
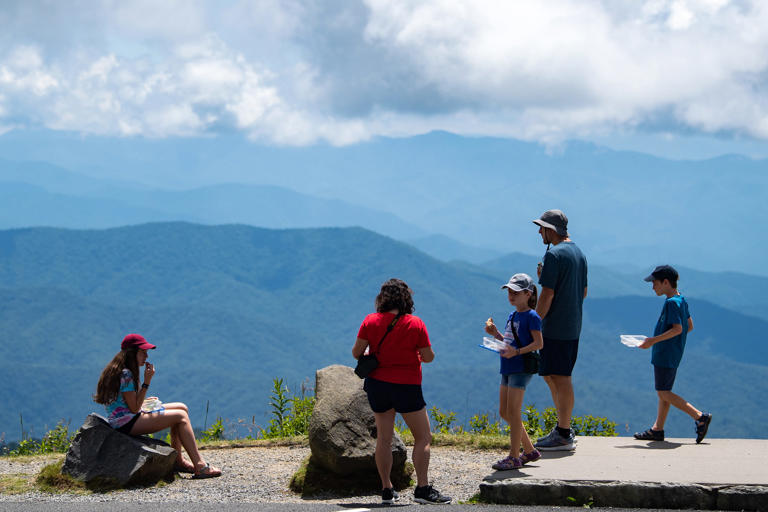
0;222;768;440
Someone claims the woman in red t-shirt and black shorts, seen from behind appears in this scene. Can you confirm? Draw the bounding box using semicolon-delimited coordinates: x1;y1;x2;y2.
352;279;451;503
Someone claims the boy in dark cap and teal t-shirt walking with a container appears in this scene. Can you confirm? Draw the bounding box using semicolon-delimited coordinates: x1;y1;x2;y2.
635;265;712;443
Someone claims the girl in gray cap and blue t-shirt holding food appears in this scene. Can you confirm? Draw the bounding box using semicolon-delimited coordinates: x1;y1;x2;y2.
485;274;544;471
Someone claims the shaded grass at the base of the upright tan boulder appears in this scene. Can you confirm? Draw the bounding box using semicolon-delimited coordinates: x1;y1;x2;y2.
289;455;414;497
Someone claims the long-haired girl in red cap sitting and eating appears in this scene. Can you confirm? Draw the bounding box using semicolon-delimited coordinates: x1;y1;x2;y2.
93;334;221;478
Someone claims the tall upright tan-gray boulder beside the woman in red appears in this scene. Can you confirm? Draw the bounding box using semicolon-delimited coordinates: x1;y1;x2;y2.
309;365;407;475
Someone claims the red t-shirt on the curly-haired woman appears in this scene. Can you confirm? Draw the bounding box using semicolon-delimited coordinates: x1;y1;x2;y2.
357;313;431;384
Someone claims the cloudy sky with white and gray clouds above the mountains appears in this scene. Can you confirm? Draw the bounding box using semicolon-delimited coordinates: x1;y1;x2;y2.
0;0;768;158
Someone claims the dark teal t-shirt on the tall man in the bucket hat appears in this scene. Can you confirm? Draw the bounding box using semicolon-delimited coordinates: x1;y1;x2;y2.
539;242;587;340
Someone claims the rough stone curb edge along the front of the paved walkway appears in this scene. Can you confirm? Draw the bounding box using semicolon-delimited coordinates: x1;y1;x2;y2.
480;479;768;510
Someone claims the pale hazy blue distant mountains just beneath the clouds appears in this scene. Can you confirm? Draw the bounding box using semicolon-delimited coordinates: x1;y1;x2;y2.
0;131;768;276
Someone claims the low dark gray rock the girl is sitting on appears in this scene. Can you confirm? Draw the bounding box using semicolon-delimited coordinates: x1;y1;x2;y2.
61;414;176;487
